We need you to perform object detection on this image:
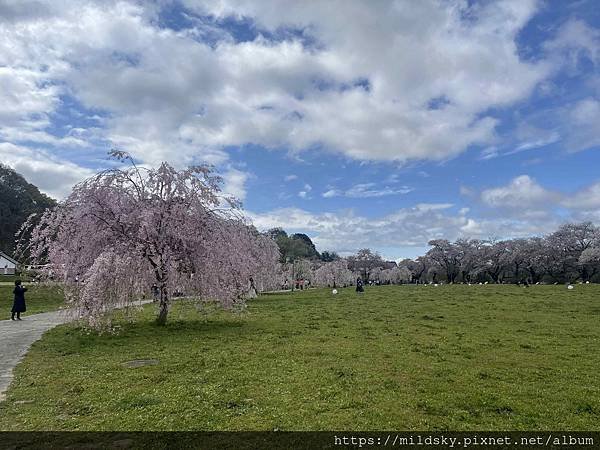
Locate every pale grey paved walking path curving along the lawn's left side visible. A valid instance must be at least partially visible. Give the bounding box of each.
[0,300,151,402]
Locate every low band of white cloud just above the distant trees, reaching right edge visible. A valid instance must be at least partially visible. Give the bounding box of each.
[249,175,600,258]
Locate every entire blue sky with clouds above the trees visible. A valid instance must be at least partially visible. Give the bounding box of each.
[0,0,600,259]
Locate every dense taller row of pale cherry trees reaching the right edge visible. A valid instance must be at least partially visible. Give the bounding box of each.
[414,222,600,283]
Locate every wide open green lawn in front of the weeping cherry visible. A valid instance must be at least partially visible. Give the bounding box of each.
[0,285,600,430]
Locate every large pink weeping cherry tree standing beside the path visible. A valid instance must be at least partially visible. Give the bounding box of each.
[20,151,279,324]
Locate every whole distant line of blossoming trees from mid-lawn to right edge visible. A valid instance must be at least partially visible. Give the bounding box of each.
[288,222,600,286]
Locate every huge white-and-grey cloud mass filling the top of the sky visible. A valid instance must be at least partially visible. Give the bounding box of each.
[0,0,549,172]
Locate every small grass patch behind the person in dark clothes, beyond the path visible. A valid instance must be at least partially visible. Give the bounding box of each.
[0,283,64,316]
